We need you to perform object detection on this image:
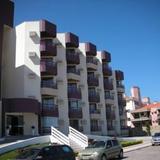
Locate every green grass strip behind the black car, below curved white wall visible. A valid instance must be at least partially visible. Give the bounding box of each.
[0,143,48,160]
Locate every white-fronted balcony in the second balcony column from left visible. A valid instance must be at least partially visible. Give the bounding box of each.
[67,68,80,81]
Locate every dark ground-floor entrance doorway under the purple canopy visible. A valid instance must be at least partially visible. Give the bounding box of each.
[6,115,23,136]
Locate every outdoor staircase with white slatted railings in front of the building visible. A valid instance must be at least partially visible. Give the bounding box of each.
[50,127,88,152]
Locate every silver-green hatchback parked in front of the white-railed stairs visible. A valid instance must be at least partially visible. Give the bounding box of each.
[78,138,123,160]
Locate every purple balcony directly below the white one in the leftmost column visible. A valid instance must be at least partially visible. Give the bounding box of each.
[42,104,59,117]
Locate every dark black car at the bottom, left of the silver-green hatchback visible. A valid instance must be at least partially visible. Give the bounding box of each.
[16,145,75,160]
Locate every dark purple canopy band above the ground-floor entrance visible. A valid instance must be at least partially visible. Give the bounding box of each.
[2,98,40,114]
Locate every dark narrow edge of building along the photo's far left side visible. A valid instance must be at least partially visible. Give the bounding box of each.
[0,0,14,135]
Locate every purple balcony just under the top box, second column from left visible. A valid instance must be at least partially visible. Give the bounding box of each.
[66,52,80,65]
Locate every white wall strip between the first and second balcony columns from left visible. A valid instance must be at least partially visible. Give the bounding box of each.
[57,33,69,134]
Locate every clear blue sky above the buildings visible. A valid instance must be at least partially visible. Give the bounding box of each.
[14,0,160,101]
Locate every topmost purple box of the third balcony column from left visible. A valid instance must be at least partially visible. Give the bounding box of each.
[85,43,97,56]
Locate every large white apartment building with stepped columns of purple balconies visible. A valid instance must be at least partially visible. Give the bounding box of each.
[2,20,128,138]
